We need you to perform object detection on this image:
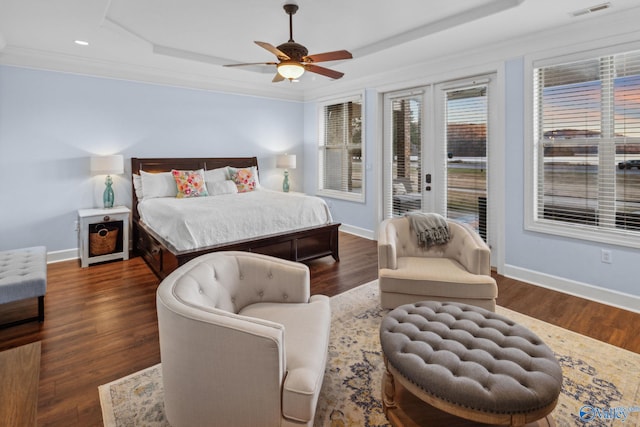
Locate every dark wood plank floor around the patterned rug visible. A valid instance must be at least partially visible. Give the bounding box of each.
[0,233,640,427]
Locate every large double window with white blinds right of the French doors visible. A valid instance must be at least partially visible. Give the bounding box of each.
[532,51,640,246]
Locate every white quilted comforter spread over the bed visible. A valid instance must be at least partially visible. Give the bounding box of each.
[138,189,332,251]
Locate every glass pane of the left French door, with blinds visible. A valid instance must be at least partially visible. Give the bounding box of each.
[391,95,422,216]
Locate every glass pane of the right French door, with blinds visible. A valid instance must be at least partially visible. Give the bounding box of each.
[445,85,488,240]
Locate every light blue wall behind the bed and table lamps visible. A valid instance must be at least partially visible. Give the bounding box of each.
[0,66,304,252]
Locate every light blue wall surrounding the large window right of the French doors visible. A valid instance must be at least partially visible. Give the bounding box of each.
[504,58,640,298]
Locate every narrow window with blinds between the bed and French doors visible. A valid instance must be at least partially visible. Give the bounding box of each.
[318,96,364,201]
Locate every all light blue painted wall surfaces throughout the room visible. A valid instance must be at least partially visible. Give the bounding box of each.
[0,58,640,295]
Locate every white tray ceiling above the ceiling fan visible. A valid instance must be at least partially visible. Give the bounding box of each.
[0,0,637,98]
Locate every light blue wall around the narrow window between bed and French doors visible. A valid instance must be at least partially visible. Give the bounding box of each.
[304,89,379,237]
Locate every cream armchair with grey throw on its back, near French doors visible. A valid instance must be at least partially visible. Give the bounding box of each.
[378,217,498,311]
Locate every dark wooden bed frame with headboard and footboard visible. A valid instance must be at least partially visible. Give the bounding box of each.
[131,157,340,279]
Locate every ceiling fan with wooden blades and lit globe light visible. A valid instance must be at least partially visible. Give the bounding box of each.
[225,4,353,83]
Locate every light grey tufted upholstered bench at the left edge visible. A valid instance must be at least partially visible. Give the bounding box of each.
[0,246,47,327]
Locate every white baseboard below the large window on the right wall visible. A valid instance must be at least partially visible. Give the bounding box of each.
[503,265,640,313]
